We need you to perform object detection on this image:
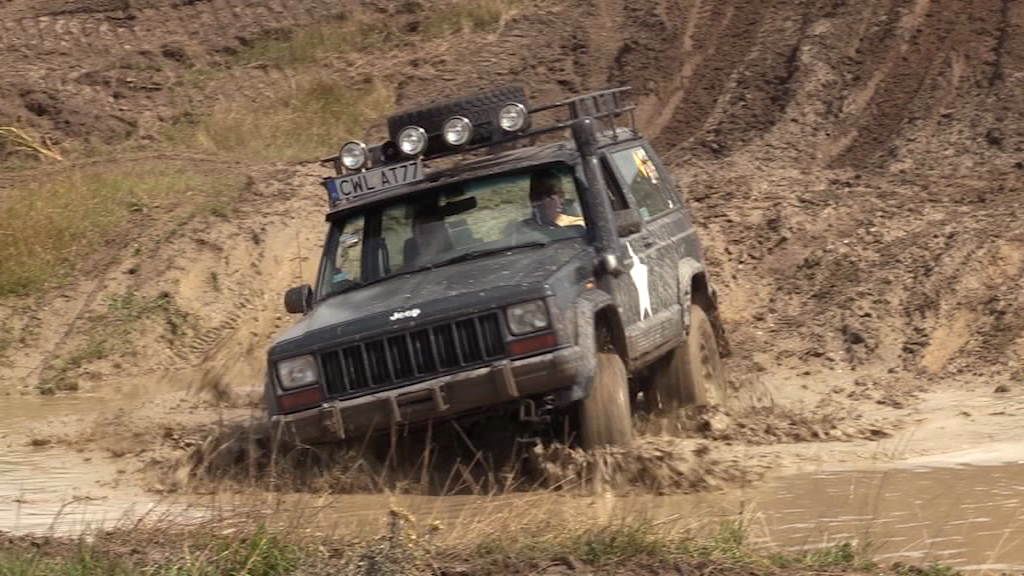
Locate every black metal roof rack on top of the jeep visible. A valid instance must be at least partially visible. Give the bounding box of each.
[319,86,637,175]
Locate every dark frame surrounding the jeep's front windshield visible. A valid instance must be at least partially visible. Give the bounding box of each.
[313,155,594,301]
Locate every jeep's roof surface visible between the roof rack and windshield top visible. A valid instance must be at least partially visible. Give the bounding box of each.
[327,128,643,219]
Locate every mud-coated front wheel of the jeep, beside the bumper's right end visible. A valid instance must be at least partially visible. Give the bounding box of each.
[580,344,633,450]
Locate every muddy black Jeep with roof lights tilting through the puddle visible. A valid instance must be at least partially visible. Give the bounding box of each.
[266,86,727,447]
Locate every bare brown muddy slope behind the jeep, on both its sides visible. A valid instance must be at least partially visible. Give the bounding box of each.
[0,0,1024,389]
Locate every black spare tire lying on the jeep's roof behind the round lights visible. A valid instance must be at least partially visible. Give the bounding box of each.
[387,84,526,141]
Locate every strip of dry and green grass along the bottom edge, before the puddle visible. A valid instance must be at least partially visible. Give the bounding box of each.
[0,500,929,576]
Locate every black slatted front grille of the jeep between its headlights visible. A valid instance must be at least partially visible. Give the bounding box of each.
[321,312,507,396]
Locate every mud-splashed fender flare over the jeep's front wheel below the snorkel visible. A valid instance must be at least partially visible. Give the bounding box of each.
[555,290,629,406]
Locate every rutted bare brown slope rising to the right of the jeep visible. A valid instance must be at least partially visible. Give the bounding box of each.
[389,0,1024,373]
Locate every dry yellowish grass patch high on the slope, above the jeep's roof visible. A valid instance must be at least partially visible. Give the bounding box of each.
[164,0,522,161]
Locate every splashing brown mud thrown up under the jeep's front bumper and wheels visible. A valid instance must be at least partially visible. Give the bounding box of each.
[161,399,889,495]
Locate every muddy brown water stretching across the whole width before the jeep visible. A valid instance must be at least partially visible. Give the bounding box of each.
[0,395,1024,571]
